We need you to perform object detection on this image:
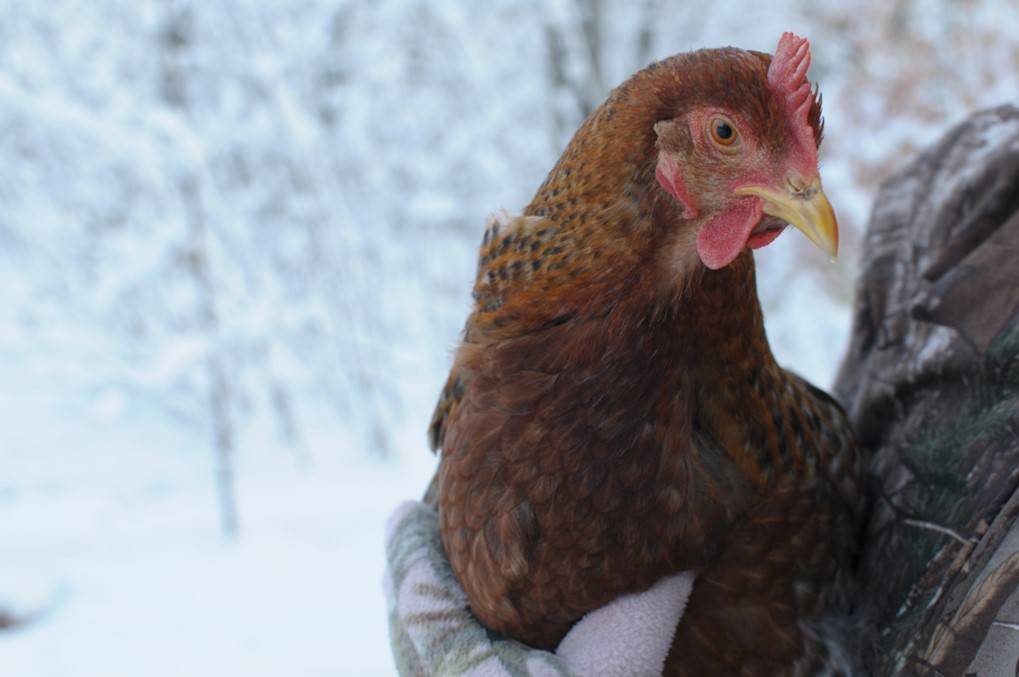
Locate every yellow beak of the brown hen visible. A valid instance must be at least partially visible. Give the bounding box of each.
[736,177,839,259]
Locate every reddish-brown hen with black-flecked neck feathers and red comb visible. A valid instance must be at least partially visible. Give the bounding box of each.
[430,34,861,675]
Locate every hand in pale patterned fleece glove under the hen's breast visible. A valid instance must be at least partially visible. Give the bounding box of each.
[384,502,693,677]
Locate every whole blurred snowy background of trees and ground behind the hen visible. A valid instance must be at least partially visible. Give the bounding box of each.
[0,0,1019,677]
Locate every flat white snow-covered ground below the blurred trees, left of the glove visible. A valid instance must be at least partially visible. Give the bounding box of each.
[0,465,434,677]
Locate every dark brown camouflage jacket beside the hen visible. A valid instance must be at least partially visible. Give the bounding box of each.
[835,106,1019,677]
